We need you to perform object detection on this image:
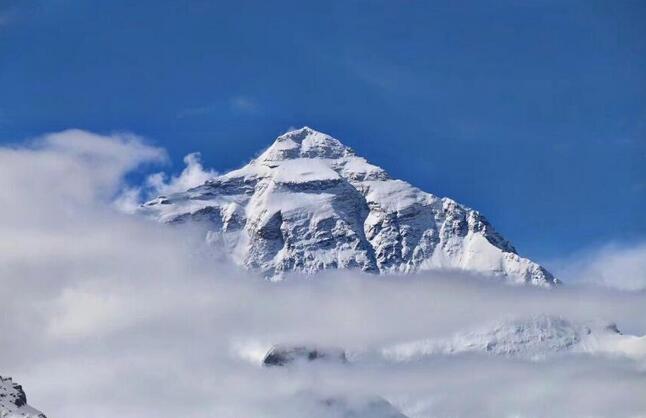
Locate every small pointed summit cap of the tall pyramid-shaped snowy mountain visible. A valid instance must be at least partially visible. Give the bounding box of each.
[259,126,354,161]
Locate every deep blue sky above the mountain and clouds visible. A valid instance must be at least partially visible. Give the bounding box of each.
[0,0,646,260]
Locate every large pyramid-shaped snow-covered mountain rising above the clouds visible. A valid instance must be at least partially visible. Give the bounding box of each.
[141,127,556,286]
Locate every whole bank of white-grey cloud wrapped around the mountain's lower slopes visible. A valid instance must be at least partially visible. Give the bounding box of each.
[0,130,646,418]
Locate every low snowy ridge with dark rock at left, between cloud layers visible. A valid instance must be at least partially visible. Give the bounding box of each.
[253,315,646,367]
